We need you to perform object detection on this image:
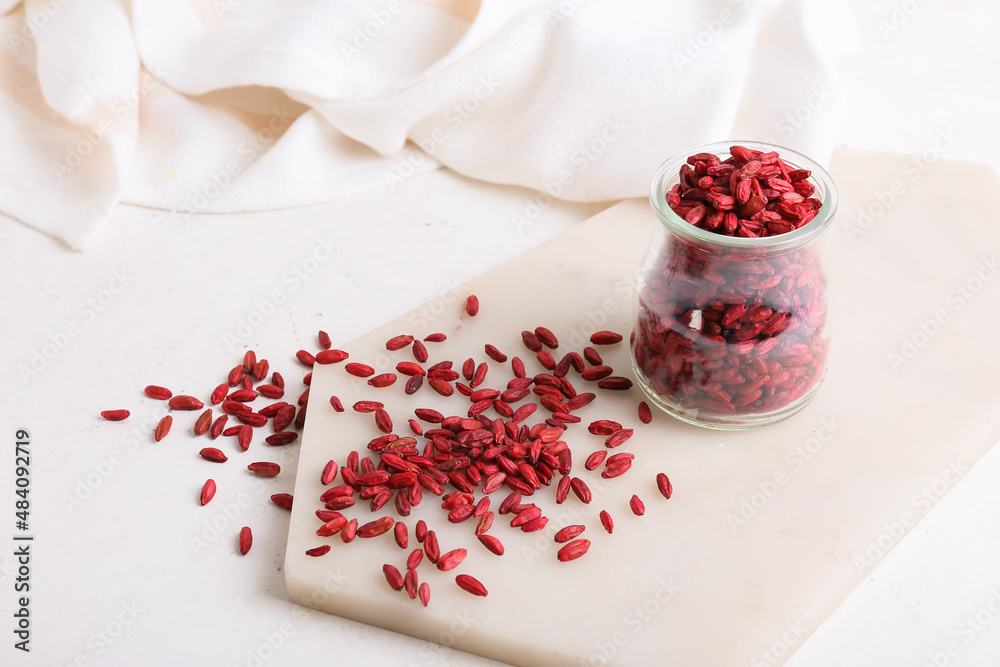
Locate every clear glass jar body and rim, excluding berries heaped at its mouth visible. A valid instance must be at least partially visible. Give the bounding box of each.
[632,141,837,429]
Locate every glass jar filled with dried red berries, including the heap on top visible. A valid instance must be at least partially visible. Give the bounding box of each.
[632,141,837,429]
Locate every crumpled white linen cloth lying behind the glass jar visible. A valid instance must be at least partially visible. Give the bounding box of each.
[0,0,851,249]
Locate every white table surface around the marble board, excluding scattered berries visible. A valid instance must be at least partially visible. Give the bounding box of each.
[0,0,1000,667]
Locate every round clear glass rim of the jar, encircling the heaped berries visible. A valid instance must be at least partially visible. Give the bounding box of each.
[649,139,838,251]
